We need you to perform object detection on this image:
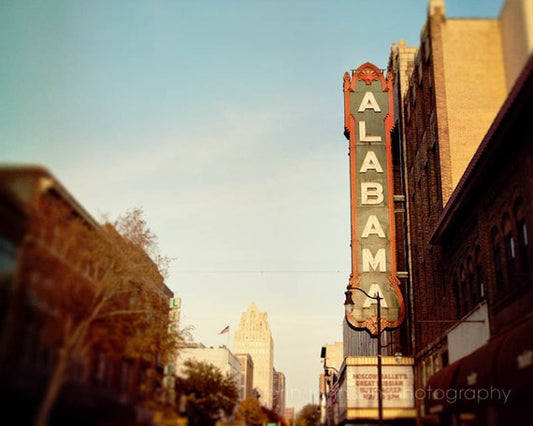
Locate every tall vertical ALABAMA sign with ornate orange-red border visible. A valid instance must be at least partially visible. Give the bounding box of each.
[343,62,405,334]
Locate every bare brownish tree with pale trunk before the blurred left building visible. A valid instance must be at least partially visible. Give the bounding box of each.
[26,198,177,426]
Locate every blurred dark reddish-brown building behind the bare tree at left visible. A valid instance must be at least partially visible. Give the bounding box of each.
[0,166,172,425]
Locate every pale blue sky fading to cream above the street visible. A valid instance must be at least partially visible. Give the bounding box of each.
[0,0,502,410]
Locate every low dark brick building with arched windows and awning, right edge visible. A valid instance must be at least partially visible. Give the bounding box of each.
[420,57,533,425]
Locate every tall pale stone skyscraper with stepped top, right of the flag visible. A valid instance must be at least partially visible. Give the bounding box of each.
[233,302,274,408]
